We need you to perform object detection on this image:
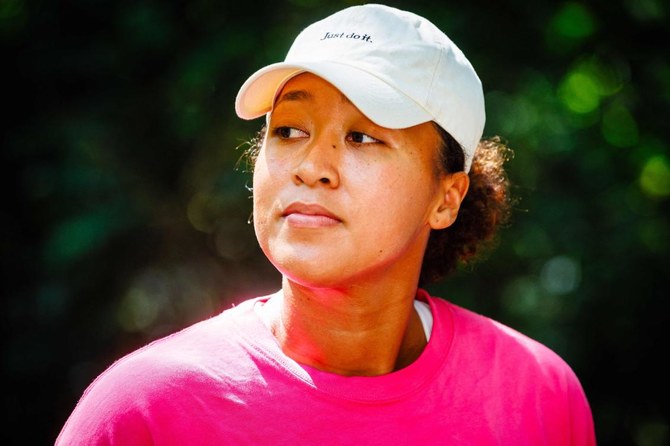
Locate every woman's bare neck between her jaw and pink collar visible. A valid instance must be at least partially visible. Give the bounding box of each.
[263,278,426,376]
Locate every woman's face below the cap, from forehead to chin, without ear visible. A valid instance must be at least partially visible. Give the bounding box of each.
[253,74,452,287]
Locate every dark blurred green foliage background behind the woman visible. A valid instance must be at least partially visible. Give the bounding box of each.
[0,0,670,446]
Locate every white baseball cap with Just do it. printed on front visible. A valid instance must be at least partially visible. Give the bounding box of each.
[235,4,486,172]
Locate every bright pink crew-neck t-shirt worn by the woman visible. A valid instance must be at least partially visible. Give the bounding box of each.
[56,291,595,446]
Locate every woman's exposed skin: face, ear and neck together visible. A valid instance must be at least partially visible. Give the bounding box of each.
[254,74,468,375]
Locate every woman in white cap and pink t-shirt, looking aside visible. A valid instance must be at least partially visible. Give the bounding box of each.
[57,5,595,445]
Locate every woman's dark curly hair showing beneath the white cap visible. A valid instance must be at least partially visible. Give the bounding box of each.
[242,123,512,286]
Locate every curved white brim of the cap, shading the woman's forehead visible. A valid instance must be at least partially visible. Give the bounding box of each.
[235,61,433,129]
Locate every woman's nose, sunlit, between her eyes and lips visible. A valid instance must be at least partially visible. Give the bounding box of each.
[293,138,341,188]
